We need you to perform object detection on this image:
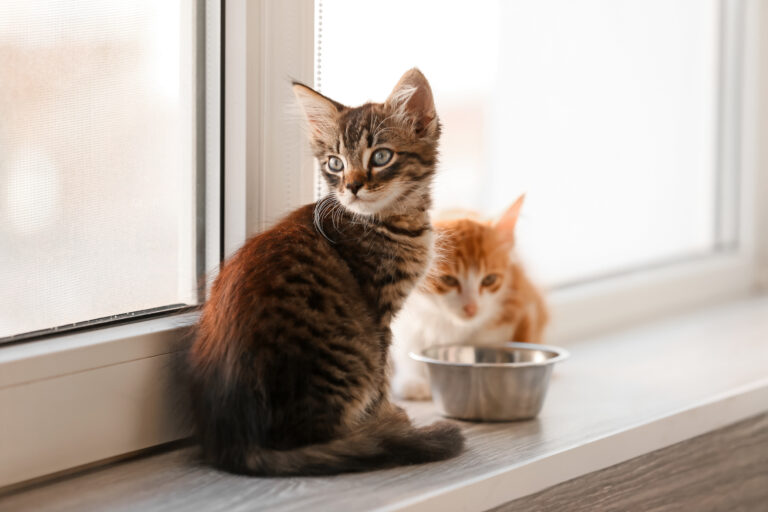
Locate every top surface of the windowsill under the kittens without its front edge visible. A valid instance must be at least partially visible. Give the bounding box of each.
[0,298,768,512]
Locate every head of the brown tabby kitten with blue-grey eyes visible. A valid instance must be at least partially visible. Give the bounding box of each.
[293,68,440,215]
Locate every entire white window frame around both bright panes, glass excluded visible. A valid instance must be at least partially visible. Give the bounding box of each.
[0,0,768,487]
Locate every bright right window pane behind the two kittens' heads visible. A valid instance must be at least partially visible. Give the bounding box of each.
[316,0,737,286]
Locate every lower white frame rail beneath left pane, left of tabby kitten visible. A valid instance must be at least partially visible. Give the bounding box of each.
[0,312,198,488]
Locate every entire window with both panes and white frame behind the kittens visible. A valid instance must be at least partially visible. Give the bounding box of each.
[0,0,768,486]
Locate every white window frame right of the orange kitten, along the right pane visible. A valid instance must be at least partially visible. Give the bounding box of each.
[549,0,768,343]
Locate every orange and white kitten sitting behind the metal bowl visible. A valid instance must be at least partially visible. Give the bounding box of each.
[391,196,548,400]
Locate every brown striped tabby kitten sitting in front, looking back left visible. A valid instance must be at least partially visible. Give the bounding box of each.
[188,69,464,475]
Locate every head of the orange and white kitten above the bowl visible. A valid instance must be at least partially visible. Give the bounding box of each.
[422,196,524,324]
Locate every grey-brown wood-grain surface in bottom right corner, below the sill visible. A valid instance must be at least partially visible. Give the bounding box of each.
[494,415,768,512]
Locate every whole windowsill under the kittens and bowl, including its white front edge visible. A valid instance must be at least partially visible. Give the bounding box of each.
[4,296,768,510]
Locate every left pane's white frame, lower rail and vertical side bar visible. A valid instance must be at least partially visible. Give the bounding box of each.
[0,0,228,487]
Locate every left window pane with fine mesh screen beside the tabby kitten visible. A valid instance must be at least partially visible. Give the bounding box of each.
[0,0,210,340]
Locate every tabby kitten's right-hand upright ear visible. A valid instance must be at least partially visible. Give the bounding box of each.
[385,68,438,136]
